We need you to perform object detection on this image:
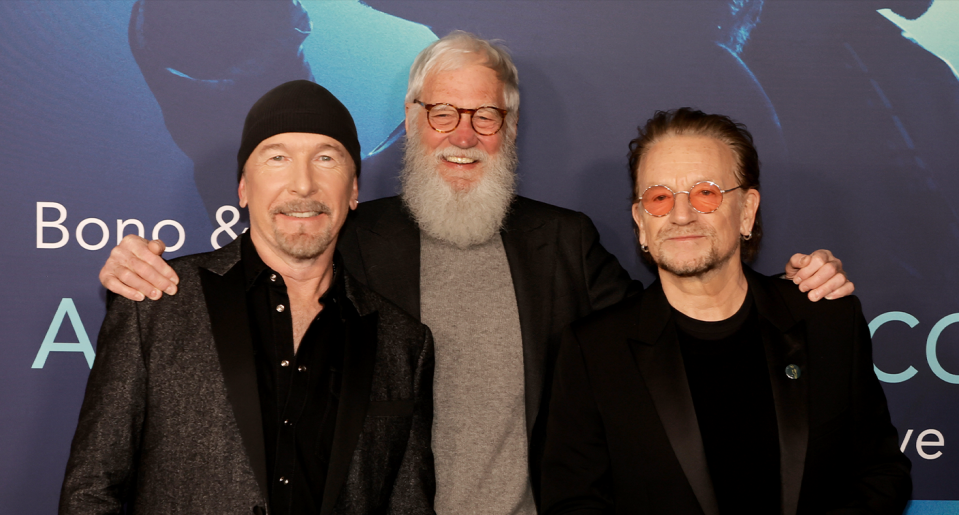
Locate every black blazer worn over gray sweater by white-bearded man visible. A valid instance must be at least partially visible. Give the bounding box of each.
[337,197,642,502]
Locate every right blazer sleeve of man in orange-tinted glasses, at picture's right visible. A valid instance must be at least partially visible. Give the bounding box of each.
[832,297,912,515]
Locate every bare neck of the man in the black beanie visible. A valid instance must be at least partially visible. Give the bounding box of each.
[250,230,336,300]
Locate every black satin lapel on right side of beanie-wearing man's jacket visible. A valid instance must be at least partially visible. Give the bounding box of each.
[320,311,379,515]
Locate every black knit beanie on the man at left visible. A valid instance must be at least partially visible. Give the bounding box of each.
[236,80,360,181]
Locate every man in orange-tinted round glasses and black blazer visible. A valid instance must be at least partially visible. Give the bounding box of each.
[543,108,912,515]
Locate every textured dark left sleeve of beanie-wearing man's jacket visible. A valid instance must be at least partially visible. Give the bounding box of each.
[59,298,146,515]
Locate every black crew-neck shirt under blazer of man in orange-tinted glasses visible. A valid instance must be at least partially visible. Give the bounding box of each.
[673,293,782,514]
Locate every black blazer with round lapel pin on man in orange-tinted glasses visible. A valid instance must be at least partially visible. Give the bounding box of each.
[543,269,912,515]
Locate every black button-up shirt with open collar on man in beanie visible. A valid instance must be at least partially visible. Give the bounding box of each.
[241,235,349,515]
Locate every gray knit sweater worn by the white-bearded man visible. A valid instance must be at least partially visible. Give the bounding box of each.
[420,234,536,515]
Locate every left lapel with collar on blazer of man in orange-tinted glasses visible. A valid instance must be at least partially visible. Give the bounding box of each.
[630,281,719,515]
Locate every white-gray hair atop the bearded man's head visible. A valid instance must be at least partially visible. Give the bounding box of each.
[406,30,519,134]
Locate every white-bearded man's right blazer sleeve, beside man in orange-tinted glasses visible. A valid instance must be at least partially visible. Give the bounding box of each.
[579,214,643,311]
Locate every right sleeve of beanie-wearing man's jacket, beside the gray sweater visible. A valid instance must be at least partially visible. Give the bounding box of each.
[390,326,436,515]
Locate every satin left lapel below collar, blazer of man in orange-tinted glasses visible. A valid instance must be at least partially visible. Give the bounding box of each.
[631,322,719,515]
